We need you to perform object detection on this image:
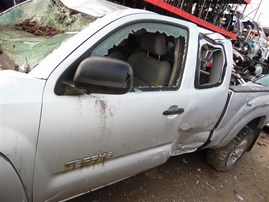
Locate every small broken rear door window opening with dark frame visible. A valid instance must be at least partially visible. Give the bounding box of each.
[196,43,225,87]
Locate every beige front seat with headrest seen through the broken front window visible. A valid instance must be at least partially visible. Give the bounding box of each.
[128,33,171,86]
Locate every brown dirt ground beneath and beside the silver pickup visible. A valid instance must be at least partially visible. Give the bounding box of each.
[70,130,269,202]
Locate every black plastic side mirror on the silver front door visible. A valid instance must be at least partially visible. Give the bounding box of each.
[73,56,133,94]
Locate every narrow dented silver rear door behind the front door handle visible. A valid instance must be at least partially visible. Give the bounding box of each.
[179,37,231,151]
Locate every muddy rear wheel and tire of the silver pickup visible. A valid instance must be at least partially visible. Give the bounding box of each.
[207,126,255,171]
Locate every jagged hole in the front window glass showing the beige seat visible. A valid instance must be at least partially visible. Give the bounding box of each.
[106,30,185,88]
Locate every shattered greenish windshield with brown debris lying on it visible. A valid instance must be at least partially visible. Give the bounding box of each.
[0,0,96,73]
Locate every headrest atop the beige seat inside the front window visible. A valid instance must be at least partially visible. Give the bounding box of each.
[140,33,166,56]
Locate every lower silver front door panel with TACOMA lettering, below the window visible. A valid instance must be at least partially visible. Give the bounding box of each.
[35,90,186,200]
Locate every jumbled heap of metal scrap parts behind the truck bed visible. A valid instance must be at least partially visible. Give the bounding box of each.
[232,21,269,85]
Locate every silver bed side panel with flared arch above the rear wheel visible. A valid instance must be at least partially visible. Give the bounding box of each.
[207,92,269,147]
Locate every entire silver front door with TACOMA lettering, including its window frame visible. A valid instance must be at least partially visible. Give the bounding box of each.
[34,18,188,200]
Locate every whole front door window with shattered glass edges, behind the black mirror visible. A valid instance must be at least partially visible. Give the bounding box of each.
[55,23,188,95]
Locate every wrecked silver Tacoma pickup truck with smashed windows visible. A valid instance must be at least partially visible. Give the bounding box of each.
[0,0,269,201]
